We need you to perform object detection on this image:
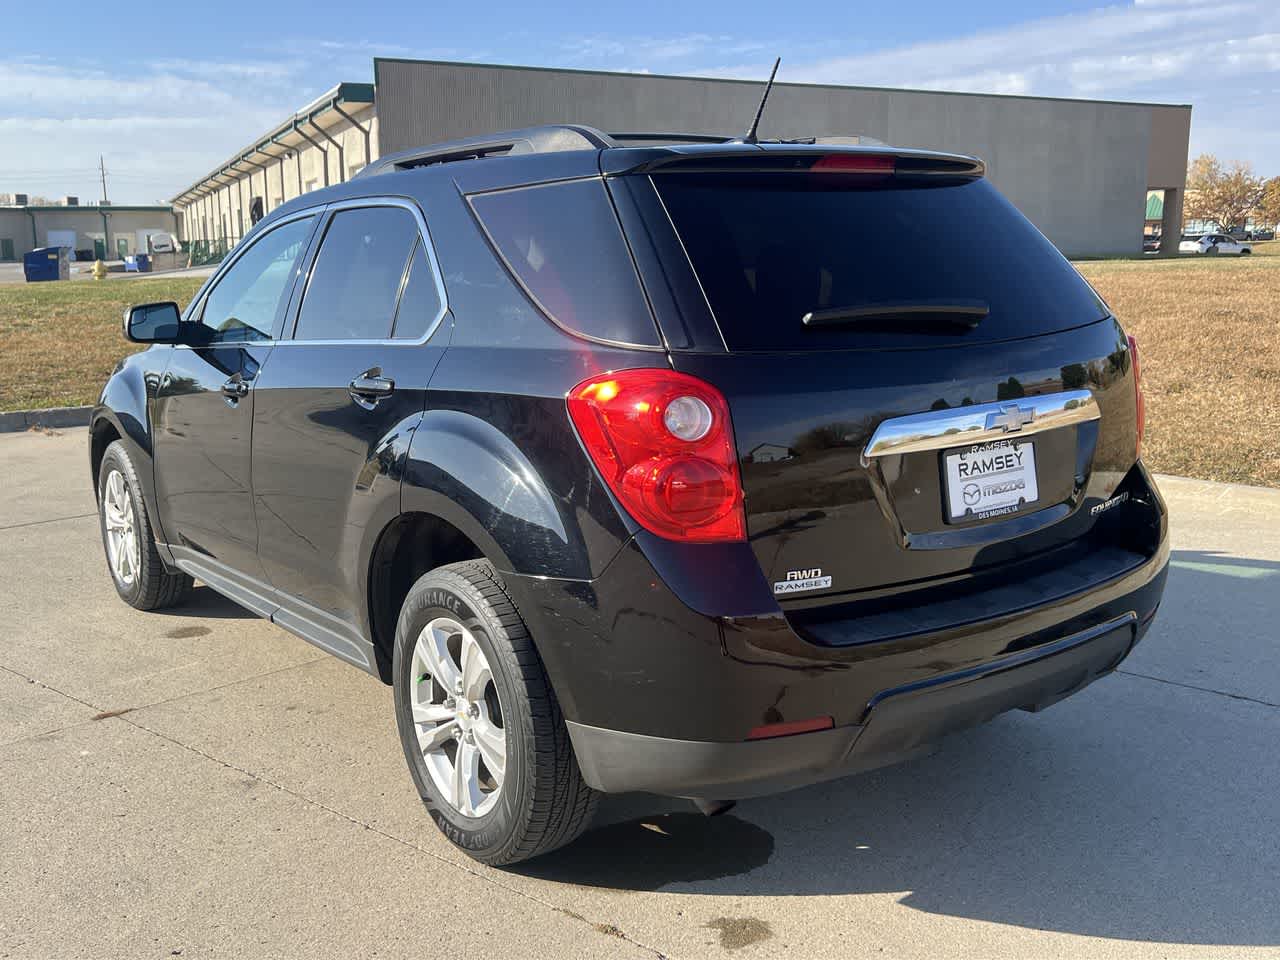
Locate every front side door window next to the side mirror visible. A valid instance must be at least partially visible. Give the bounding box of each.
[197,216,311,343]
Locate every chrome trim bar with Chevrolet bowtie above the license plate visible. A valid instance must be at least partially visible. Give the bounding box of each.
[863,390,1101,465]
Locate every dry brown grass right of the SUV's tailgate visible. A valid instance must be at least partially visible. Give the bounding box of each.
[1079,242,1280,486]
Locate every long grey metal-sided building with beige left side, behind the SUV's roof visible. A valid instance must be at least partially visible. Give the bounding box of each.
[173,59,1192,256]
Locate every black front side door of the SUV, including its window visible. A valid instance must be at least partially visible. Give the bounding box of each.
[152,215,316,586]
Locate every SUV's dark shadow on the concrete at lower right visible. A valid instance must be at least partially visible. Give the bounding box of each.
[520,552,1280,946]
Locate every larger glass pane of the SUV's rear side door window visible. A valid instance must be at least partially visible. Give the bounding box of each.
[293,206,417,340]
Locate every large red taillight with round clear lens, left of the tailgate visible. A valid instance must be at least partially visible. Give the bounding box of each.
[567,370,746,543]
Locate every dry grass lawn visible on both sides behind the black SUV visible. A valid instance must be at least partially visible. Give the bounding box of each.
[0,241,1280,486]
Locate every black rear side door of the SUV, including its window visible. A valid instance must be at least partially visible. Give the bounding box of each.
[253,198,451,666]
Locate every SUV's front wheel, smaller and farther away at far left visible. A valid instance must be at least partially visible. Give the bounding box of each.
[97,440,192,611]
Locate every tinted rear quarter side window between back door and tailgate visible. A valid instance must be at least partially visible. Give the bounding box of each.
[471,179,659,347]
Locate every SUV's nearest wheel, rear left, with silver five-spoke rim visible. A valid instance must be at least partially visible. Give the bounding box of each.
[393,561,596,865]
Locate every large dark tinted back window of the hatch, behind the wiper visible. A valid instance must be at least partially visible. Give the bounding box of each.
[654,173,1107,351]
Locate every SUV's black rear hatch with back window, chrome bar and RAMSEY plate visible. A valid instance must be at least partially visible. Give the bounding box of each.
[614,148,1137,608]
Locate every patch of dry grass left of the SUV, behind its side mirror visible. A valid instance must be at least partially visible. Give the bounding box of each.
[0,276,204,412]
